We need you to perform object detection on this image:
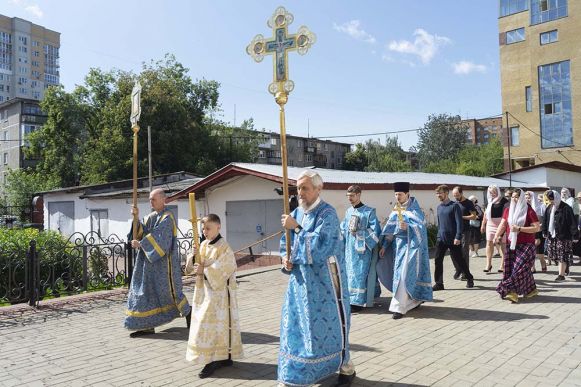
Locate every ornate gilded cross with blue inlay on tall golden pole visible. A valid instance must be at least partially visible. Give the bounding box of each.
[246,7,316,257]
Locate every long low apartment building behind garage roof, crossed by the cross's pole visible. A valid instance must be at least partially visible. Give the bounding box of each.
[256,132,351,169]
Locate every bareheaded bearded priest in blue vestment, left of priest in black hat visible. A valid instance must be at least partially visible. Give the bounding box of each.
[341,185,381,312]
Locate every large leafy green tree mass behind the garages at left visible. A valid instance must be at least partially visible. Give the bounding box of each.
[27,55,254,187]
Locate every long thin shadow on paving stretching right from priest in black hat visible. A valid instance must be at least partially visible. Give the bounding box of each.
[406,306,554,321]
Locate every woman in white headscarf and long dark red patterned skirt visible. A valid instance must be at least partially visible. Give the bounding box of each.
[495,189,540,303]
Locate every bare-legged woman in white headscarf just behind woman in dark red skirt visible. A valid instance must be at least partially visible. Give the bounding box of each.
[480,185,508,273]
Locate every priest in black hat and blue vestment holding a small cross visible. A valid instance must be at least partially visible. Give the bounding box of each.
[380,182,433,319]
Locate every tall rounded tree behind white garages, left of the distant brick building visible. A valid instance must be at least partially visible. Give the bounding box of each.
[417,113,468,172]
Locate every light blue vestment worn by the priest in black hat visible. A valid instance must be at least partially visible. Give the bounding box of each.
[382,197,433,313]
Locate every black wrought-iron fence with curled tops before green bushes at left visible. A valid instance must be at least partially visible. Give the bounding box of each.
[0,232,197,306]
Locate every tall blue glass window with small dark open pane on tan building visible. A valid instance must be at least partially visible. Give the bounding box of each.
[539,60,573,148]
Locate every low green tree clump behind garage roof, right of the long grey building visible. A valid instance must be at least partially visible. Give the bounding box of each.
[344,136,411,172]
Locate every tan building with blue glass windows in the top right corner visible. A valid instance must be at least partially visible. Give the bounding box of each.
[498,0,581,169]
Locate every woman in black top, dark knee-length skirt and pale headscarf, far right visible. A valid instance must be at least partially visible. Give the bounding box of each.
[543,191,579,281]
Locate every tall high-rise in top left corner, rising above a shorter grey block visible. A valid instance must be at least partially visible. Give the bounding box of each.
[0,15,60,103]
